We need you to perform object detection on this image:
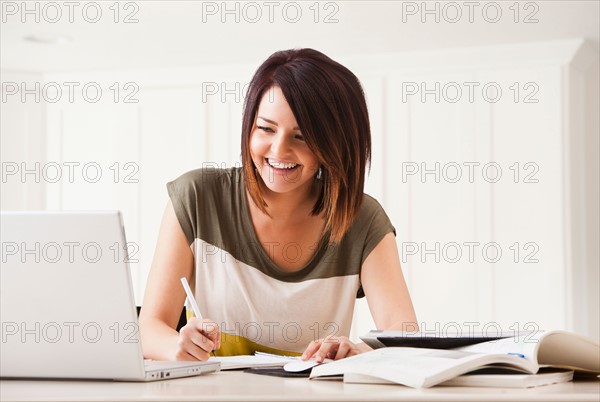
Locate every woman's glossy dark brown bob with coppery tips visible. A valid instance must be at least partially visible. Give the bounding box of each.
[242,48,371,243]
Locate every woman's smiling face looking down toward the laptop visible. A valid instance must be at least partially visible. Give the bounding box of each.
[250,86,319,193]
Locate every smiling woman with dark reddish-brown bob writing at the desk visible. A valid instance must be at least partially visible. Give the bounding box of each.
[140,49,417,361]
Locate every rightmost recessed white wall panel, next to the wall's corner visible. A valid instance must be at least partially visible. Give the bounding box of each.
[484,67,567,328]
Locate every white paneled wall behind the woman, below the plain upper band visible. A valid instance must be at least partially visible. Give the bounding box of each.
[2,40,598,338]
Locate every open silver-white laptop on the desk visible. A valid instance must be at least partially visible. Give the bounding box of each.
[0,211,220,381]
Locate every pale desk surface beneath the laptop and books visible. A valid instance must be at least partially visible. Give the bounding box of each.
[0,371,600,402]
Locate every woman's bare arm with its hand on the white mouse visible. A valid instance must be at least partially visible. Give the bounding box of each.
[302,232,419,361]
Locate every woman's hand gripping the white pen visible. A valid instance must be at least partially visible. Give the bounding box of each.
[175,318,221,361]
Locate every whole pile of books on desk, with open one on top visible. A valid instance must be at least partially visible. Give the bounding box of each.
[310,331,600,388]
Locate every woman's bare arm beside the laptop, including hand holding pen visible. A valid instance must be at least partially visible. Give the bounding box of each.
[139,200,220,360]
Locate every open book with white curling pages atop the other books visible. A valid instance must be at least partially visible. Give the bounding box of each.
[310,331,600,388]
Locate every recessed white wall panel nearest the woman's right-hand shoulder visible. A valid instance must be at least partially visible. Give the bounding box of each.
[393,72,485,329]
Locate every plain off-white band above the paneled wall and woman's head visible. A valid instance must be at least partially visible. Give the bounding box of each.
[0,0,600,72]
